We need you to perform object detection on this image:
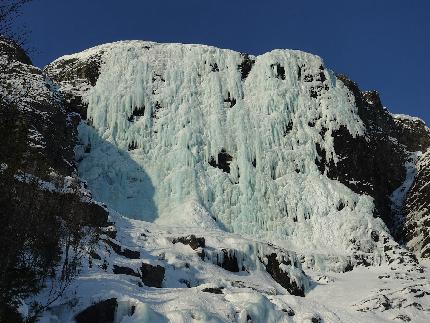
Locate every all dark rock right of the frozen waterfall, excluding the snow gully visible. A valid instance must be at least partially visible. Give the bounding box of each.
[332,75,430,257]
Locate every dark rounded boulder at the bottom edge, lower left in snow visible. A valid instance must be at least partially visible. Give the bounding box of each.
[75,298,118,323]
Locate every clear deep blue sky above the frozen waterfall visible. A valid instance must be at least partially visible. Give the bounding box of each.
[22,0,430,124]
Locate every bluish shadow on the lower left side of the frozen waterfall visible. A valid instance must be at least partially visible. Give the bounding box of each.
[76,123,158,222]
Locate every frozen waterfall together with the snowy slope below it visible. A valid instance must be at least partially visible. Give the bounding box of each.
[17,42,430,322]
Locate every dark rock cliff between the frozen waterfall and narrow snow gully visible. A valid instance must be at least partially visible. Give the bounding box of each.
[321,75,430,241]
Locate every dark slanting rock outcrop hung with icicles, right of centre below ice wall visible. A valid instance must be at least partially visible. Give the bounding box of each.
[266,253,305,296]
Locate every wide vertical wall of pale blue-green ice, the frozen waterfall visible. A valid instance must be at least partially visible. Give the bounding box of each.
[73,42,379,253]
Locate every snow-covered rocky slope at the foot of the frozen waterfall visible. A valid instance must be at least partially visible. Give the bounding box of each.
[34,209,430,323]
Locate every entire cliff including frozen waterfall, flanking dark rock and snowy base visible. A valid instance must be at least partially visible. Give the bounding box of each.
[0,40,430,322]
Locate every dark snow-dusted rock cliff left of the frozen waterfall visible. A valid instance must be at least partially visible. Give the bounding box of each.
[0,38,76,180]
